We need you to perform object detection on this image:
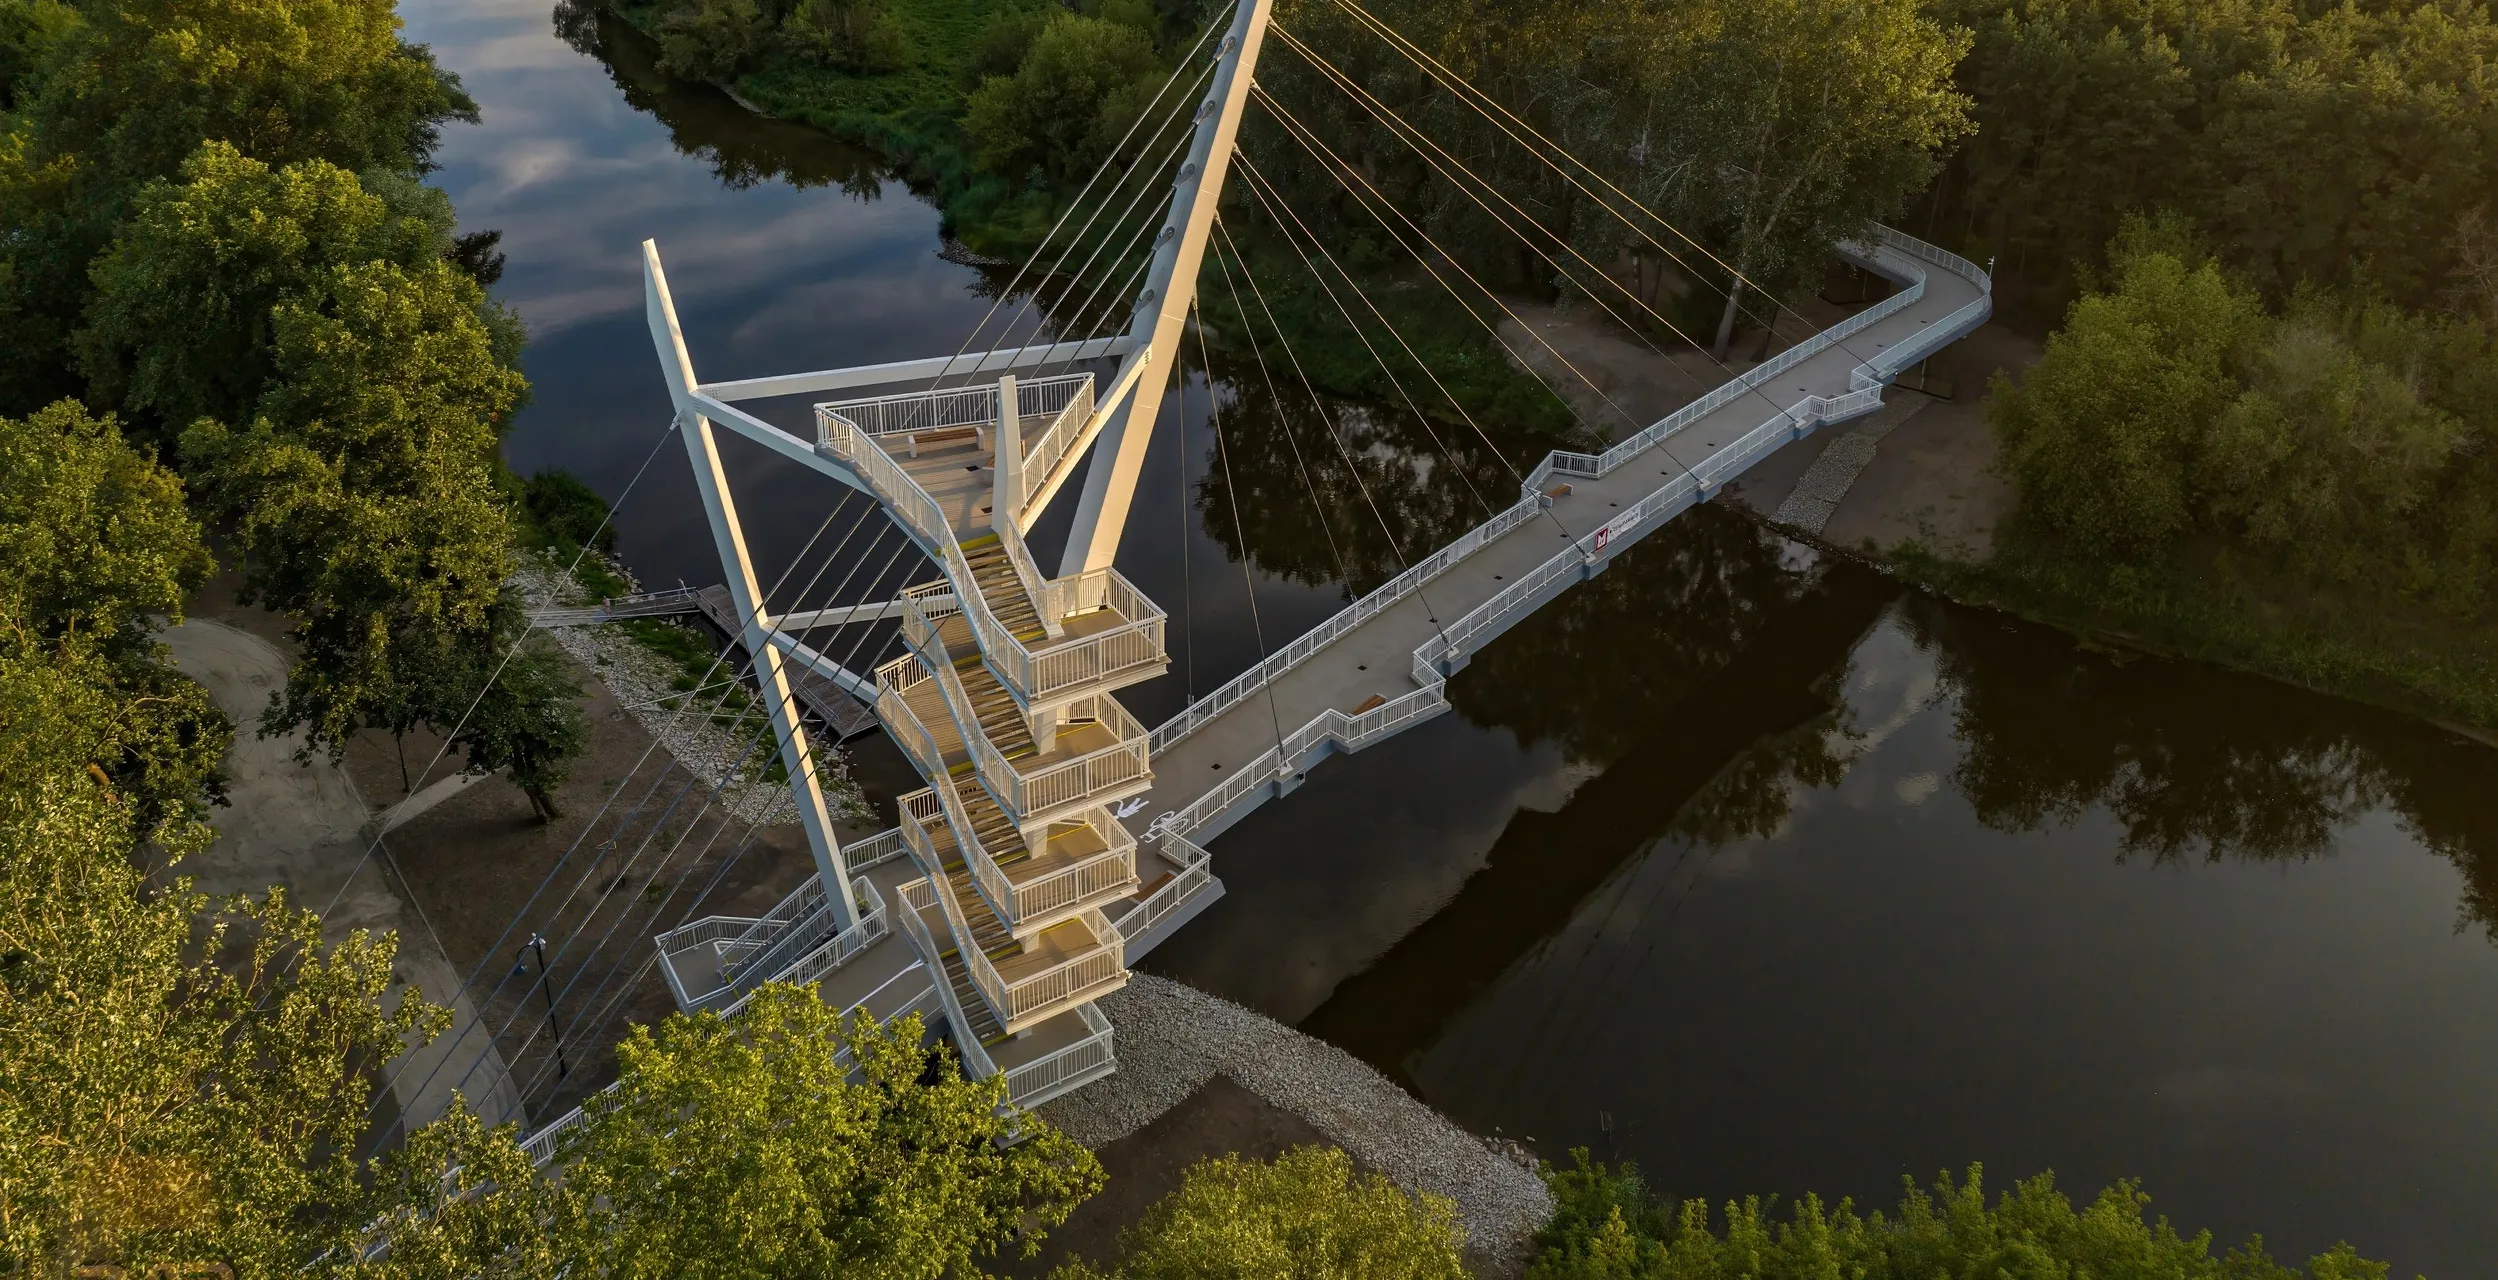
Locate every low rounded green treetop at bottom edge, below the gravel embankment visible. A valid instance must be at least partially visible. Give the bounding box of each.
[1059,1148,1466,1280]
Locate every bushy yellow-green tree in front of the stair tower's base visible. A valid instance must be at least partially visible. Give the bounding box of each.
[354,983,1102,1280]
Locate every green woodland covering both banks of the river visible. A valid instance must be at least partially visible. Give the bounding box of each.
[0,0,2458,1280]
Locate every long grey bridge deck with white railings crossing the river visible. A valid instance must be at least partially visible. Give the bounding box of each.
[1127,230,1991,890]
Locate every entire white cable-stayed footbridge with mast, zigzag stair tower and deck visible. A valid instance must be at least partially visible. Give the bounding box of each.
[517,0,1988,1150]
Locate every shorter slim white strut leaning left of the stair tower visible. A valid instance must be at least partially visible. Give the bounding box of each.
[642,240,859,930]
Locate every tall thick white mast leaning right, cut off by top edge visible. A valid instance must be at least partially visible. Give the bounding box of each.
[1059,0,1274,575]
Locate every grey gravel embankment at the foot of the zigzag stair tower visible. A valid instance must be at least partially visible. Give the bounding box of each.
[1042,973,1551,1260]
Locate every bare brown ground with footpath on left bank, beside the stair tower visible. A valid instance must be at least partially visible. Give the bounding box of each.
[175,575,892,1125]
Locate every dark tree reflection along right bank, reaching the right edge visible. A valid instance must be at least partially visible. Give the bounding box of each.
[1906,598,2498,940]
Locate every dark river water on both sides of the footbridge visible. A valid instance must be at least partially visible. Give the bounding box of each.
[407,0,2498,1278]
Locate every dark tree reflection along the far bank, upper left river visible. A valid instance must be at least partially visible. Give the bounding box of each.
[555,0,884,200]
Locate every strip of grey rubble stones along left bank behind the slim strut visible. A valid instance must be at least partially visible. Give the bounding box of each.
[512,558,864,825]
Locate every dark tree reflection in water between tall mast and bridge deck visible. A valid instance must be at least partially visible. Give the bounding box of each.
[1189,350,1519,595]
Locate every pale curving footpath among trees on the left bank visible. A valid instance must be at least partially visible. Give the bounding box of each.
[157,618,517,1125]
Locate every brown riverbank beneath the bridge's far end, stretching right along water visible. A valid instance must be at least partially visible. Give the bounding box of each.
[1578,297,2498,743]
